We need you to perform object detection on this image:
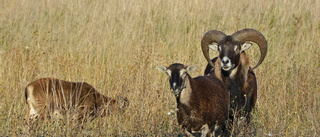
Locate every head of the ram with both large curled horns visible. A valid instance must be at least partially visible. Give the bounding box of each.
[201,29,267,76]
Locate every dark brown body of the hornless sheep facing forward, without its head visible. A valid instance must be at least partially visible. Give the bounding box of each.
[177,76,229,135]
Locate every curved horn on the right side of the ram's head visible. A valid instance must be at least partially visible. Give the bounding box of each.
[232,29,268,69]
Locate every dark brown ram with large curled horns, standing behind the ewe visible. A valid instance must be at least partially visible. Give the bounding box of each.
[201,29,267,127]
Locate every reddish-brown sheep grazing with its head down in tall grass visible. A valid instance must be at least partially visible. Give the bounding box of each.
[25,78,129,122]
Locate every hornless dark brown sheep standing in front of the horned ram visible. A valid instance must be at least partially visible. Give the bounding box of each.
[157,63,230,136]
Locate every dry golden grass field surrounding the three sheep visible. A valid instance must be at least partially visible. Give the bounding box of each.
[0,0,320,136]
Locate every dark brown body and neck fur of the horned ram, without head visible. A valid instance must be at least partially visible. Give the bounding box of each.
[205,52,257,122]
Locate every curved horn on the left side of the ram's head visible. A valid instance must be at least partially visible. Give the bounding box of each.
[201,30,227,67]
